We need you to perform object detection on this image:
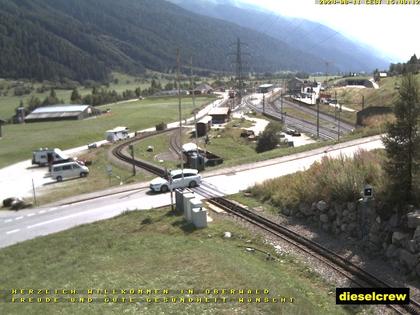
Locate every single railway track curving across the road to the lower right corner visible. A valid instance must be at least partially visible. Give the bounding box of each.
[112,124,420,315]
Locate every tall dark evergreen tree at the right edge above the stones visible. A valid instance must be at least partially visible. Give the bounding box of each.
[383,74,420,209]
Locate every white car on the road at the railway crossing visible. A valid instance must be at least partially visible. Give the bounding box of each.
[150,168,201,193]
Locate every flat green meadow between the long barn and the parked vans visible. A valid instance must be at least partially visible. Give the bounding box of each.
[0,97,214,167]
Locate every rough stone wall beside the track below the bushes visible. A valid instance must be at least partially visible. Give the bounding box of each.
[281,199,420,277]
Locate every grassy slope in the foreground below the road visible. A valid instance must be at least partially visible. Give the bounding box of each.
[0,209,363,314]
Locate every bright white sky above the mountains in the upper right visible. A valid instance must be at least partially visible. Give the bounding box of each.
[240,0,420,62]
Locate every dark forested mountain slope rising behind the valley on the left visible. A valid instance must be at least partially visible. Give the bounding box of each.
[0,0,334,81]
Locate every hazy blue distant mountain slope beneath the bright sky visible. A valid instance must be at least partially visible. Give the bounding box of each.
[169,0,389,71]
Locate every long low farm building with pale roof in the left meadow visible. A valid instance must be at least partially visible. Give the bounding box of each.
[25,105,101,123]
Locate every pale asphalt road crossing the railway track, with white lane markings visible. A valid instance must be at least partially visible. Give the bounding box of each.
[0,136,383,247]
